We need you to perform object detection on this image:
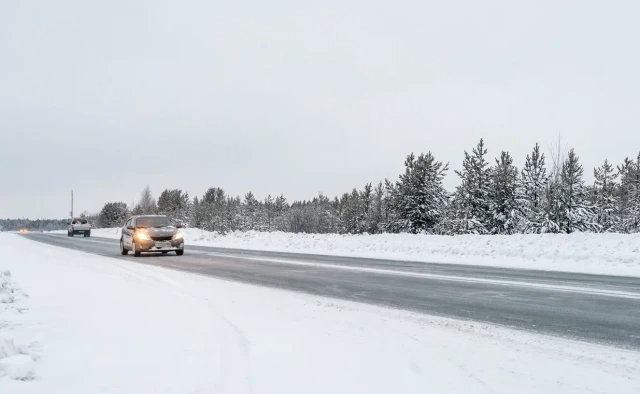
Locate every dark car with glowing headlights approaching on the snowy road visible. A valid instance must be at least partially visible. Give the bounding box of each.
[120,215,184,256]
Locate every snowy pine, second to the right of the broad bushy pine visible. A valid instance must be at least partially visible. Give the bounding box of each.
[489,151,521,234]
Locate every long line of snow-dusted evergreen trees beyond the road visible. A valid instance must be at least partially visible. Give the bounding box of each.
[98,140,640,235]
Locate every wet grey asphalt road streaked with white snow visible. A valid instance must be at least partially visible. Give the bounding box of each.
[25,233,640,349]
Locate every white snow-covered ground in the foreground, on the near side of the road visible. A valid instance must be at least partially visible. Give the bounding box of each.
[0,233,640,394]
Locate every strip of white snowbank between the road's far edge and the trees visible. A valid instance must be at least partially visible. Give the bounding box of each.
[52,228,640,276]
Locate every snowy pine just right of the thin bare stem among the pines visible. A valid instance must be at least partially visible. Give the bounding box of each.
[558,149,600,233]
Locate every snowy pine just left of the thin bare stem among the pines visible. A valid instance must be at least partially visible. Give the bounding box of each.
[518,144,557,234]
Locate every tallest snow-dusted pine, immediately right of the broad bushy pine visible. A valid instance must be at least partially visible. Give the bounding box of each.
[447,139,491,234]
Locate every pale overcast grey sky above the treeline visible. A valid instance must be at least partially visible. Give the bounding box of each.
[0,0,640,218]
